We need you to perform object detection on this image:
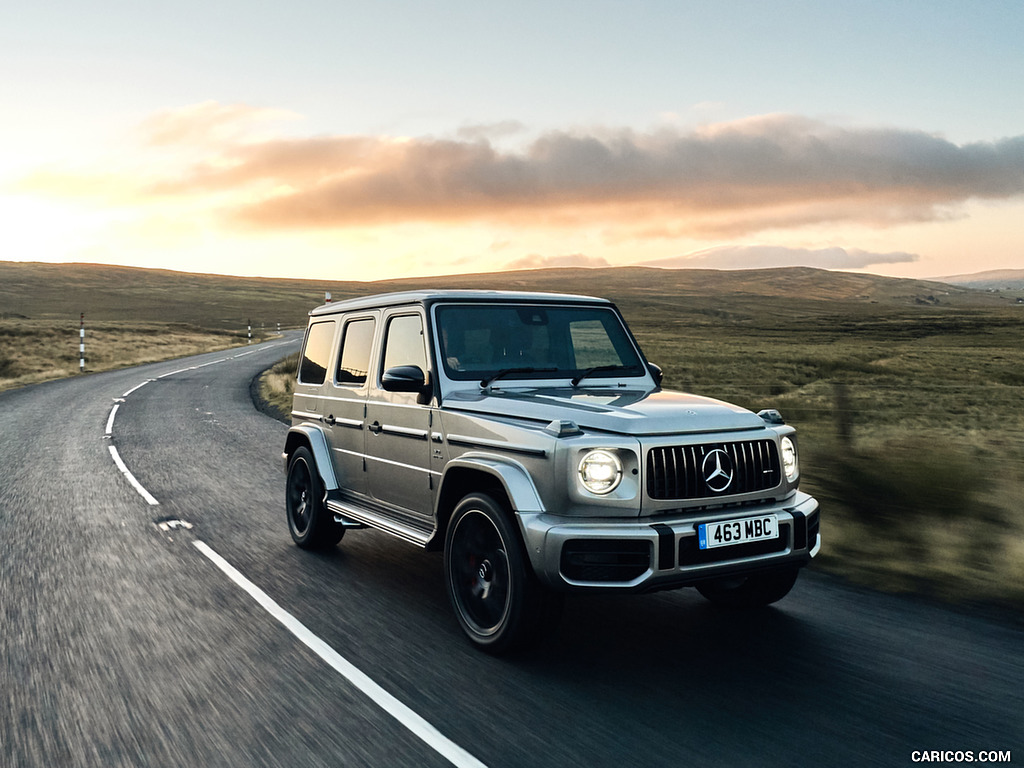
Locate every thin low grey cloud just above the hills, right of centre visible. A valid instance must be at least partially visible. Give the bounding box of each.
[639,246,920,269]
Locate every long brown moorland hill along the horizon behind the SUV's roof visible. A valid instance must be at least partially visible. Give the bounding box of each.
[0,261,1009,329]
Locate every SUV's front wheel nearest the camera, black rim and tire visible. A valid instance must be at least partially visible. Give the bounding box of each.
[444,494,561,655]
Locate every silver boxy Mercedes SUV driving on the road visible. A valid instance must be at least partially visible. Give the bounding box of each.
[283,291,821,653]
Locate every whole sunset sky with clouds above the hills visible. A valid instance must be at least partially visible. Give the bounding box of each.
[0,0,1024,281]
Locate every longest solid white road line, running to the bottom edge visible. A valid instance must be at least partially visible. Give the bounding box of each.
[194,541,485,768]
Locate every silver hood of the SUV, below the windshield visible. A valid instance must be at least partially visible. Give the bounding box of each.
[444,387,765,435]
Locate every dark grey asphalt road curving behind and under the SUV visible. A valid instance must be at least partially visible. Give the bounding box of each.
[0,342,1024,768]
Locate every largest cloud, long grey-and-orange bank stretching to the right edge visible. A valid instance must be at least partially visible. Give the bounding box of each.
[14,107,1024,240]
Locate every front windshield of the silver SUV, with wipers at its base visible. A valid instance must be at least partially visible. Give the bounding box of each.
[435,304,645,381]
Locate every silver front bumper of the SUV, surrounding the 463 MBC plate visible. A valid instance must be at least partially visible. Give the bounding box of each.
[519,493,821,592]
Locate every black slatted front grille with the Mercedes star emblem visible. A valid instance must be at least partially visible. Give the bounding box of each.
[647,440,782,500]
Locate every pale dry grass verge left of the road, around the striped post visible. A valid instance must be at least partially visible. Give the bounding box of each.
[0,319,272,390]
